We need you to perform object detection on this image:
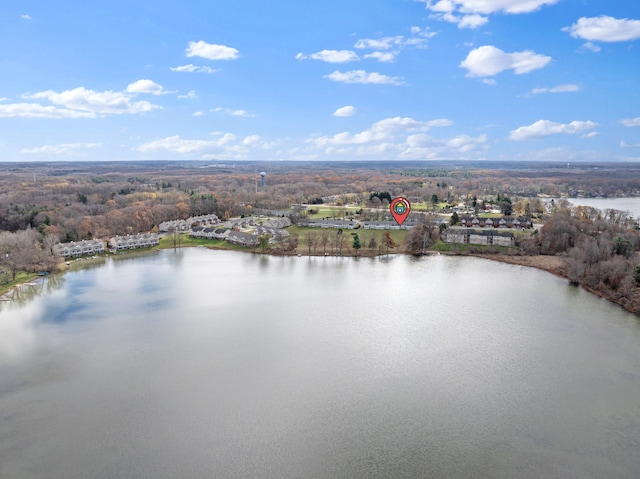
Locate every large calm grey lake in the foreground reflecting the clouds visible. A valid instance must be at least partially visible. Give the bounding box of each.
[0,249,640,479]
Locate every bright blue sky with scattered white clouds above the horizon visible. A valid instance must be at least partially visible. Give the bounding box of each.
[0,0,640,162]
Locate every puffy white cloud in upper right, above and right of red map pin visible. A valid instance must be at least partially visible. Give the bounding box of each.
[459,45,551,77]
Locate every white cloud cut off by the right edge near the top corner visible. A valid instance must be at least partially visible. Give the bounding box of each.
[562,15,640,42]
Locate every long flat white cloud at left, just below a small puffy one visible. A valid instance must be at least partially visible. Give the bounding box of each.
[23,87,162,115]
